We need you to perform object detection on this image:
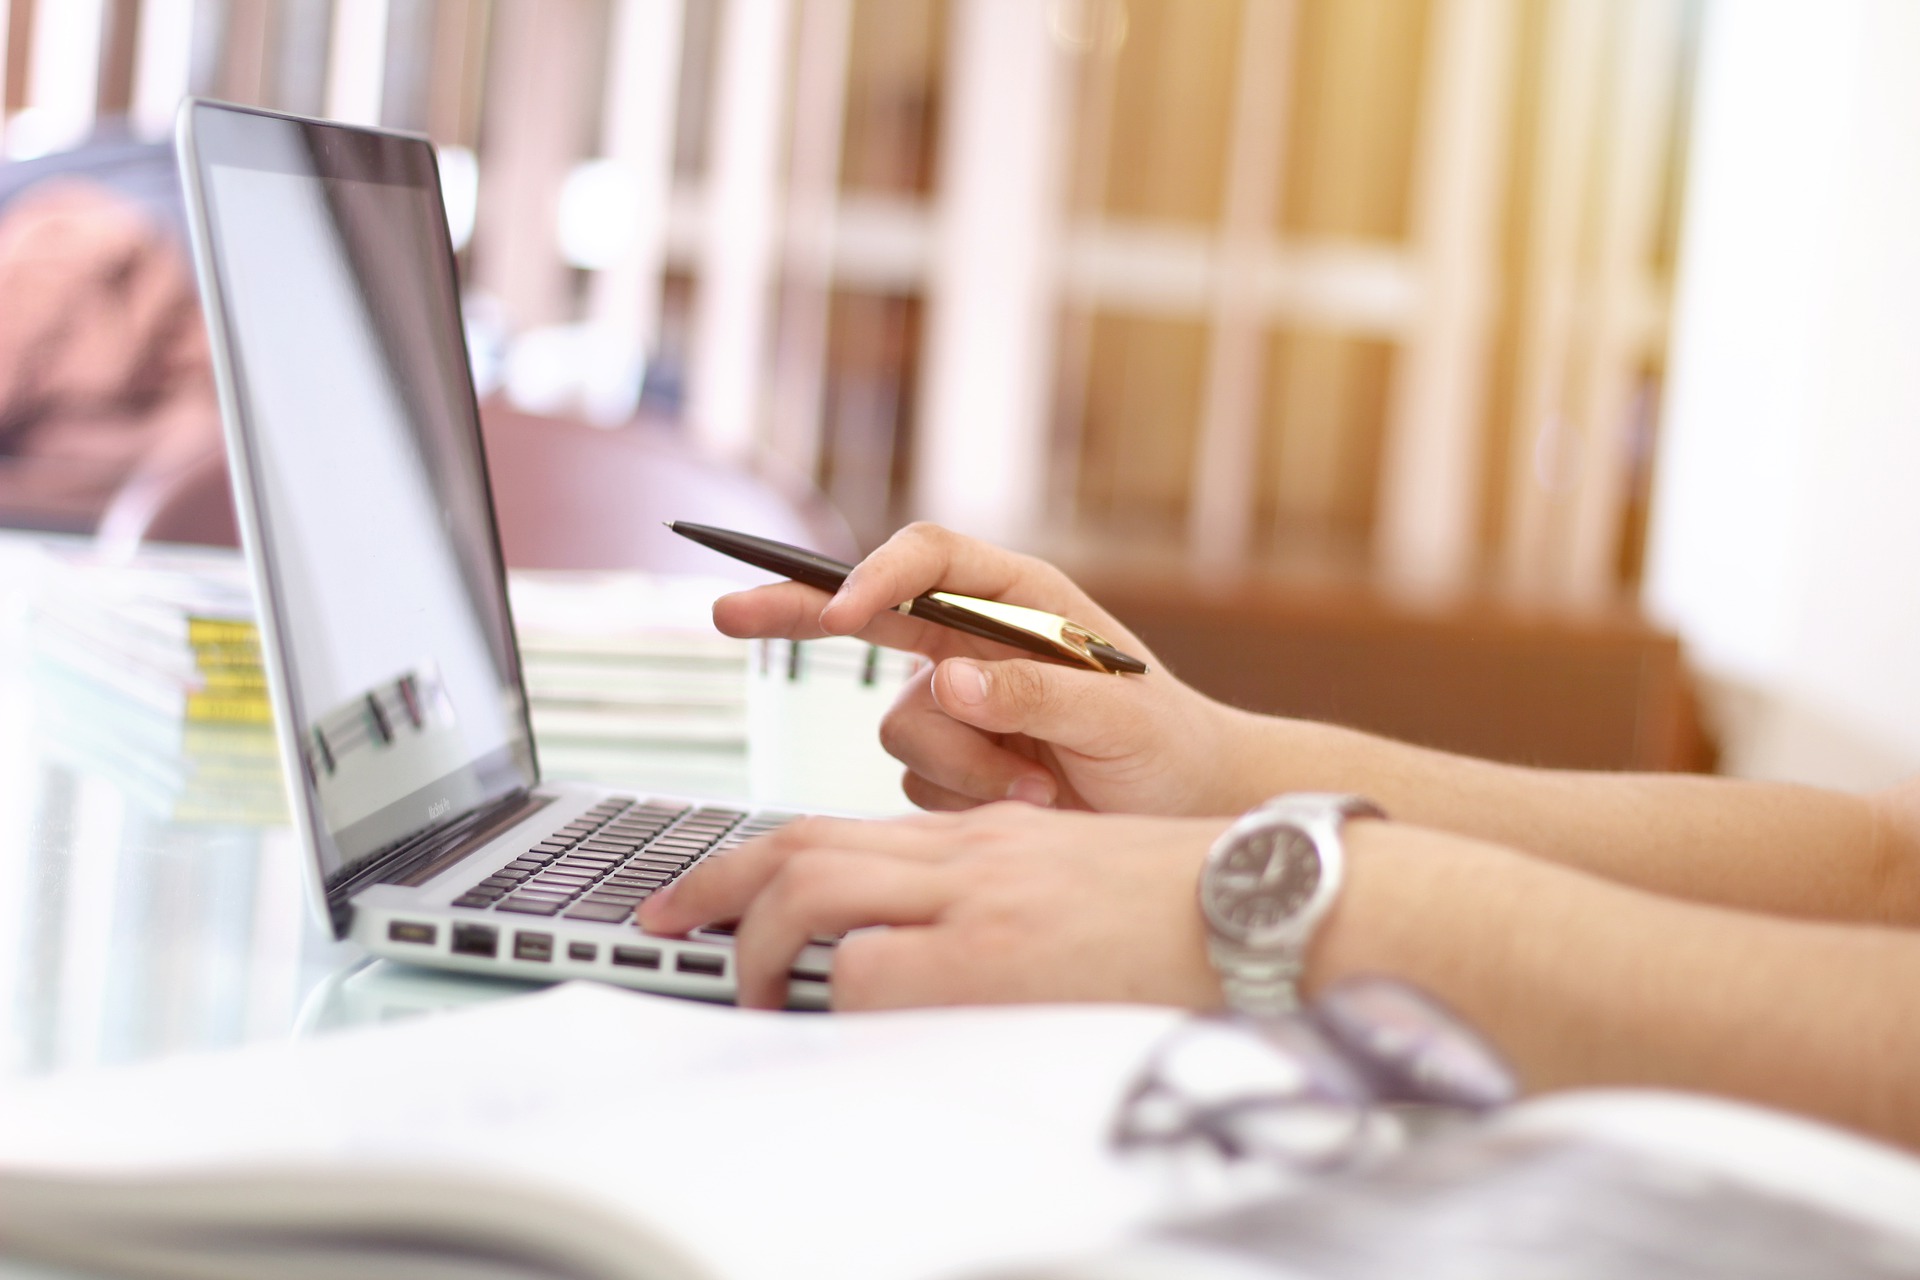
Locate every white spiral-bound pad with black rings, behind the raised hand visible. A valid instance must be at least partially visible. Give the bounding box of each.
[747,635,920,816]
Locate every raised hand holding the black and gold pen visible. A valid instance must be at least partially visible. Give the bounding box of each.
[714,524,1271,814]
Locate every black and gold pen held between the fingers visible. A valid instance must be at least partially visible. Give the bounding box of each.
[666,520,1146,676]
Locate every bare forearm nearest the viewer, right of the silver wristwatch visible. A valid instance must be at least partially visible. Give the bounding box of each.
[1309,823,1920,1146]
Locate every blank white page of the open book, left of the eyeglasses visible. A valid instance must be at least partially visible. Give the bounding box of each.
[0,984,1179,1280]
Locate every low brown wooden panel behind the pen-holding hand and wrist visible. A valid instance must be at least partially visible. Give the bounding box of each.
[1081,574,1713,770]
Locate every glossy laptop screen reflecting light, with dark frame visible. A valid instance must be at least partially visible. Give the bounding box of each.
[188,104,536,883]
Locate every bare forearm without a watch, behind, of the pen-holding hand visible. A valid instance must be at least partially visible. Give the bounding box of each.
[1229,718,1920,923]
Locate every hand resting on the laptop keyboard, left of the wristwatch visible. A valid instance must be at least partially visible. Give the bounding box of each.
[639,804,1223,1009]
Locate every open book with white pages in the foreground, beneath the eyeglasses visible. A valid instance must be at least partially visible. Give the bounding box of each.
[0,984,1920,1280]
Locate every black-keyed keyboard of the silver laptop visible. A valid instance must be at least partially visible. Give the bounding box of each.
[453,796,793,923]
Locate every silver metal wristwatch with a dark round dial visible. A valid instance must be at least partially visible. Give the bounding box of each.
[1200,791,1386,1015]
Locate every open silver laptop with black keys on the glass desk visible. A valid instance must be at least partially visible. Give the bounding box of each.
[179,100,829,1007]
